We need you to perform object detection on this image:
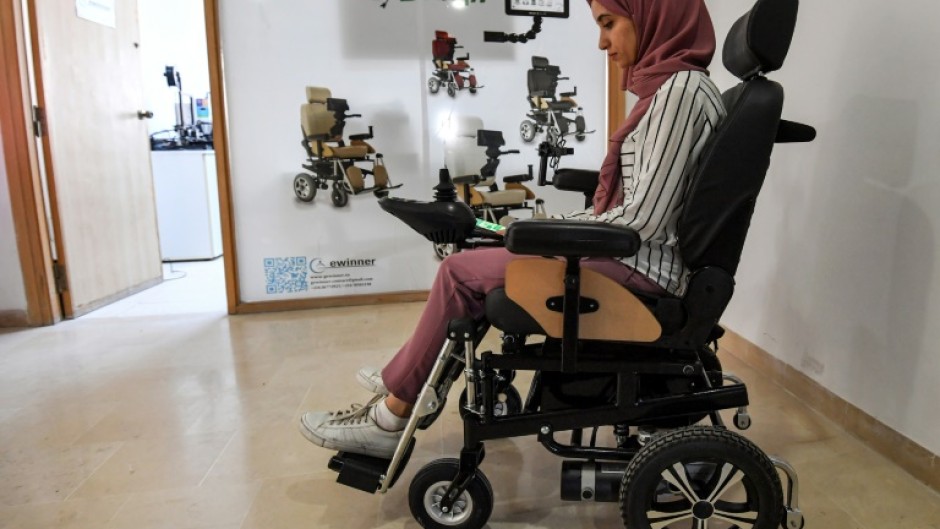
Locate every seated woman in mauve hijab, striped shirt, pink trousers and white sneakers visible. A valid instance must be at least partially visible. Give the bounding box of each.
[300,0,724,457]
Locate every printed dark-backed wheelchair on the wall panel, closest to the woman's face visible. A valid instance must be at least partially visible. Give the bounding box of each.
[519,56,593,146]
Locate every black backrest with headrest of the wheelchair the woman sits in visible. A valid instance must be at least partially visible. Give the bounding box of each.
[679,0,799,277]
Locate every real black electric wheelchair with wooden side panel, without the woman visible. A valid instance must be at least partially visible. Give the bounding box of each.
[330,0,815,529]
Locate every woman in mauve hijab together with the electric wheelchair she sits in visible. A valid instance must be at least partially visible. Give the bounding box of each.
[300,0,815,529]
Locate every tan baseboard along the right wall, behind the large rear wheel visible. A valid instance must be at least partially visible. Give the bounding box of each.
[721,331,940,492]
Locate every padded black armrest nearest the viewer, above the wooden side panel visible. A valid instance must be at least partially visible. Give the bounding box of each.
[506,219,640,257]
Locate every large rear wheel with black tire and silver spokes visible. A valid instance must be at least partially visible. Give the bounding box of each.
[620,426,783,529]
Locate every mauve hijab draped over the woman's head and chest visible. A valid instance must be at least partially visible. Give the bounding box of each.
[587,0,715,215]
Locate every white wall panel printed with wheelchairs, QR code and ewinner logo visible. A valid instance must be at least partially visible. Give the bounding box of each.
[219,0,606,302]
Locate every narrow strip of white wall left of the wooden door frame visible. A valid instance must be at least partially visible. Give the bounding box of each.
[0,124,26,313]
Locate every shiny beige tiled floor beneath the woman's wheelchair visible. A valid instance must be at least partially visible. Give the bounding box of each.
[0,266,940,529]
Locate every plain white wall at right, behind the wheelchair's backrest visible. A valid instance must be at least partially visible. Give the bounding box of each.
[708,0,940,453]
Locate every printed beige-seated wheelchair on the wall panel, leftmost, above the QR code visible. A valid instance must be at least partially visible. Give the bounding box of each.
[293,86,401,207]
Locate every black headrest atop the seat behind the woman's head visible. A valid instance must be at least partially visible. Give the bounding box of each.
[721,0,799,80]
